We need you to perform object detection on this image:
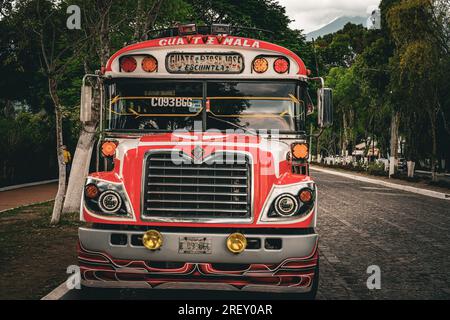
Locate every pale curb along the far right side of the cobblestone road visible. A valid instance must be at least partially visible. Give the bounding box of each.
[310,166,450,200]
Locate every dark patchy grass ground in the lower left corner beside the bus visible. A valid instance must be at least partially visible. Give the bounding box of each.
[0,202,80,300]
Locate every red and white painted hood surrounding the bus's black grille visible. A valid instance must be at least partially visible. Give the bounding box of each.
[86,133,311,228]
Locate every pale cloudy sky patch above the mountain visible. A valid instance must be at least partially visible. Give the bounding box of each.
[278,0,380,33]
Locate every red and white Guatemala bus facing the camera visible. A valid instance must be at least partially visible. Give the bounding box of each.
[78,25,332,296]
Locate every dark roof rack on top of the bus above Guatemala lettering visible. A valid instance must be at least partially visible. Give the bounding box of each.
[147,24,275,41]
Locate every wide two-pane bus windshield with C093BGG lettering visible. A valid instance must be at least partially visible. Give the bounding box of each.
[107,79,305,132]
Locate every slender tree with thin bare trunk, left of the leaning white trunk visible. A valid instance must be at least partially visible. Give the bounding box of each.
[16,0,83,224]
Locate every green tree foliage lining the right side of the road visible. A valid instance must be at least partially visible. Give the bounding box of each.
[316,0,450,172]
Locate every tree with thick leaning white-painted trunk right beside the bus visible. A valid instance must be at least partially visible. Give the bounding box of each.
[63,0,189,213]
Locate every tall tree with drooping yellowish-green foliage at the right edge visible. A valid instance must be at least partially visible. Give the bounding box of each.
[387,0,448,181]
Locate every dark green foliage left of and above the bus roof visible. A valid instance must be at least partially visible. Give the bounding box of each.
[0,0,313,184]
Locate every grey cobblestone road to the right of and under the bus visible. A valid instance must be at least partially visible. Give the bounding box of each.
[60,171,450,300]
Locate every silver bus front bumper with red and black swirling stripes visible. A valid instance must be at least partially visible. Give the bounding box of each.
[78,228,318,293]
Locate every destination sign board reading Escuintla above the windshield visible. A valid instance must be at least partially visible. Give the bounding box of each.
[166,52,244,74]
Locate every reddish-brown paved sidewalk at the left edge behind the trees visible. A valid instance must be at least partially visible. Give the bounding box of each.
[0,182,58,212]
